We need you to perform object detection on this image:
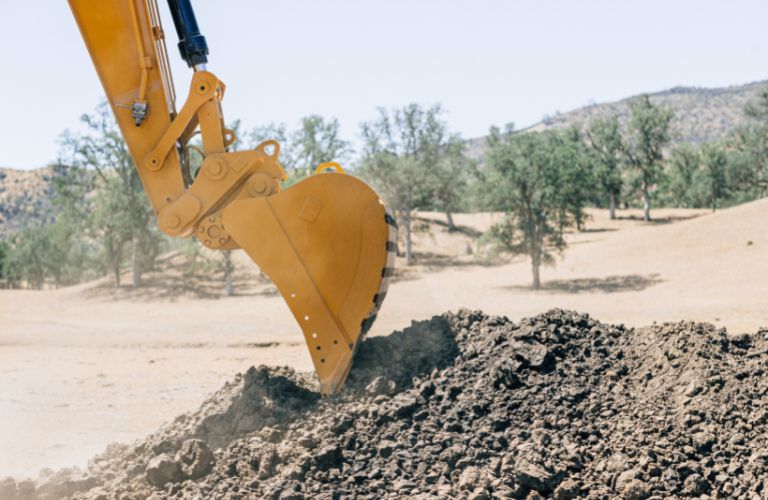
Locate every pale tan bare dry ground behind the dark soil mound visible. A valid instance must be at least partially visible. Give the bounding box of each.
[0,200,768,477]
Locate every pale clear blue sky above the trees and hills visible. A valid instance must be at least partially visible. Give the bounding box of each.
[0,0,768,168]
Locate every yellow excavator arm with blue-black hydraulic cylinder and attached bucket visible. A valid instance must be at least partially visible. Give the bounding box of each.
[69,0,397,396]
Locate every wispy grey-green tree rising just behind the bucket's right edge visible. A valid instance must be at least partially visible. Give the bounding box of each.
[359,104,455,265]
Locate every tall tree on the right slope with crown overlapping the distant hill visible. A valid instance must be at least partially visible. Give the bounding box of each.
[624,95,673,221]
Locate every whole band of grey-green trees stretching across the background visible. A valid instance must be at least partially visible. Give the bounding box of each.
[0,91,768,289]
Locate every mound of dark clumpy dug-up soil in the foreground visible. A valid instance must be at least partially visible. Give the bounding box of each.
[0,310,768,500]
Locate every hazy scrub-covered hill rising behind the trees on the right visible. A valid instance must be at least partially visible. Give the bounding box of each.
[469,81,768,161]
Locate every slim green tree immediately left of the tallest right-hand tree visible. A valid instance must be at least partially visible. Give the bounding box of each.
[586,116,624,220]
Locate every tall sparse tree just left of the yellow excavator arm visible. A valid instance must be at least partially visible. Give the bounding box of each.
[59,102,162,287]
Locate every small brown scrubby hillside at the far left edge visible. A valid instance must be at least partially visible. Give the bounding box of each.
[0,167,53,238]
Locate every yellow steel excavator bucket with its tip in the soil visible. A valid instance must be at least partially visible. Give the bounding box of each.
[223,169,397,395]
